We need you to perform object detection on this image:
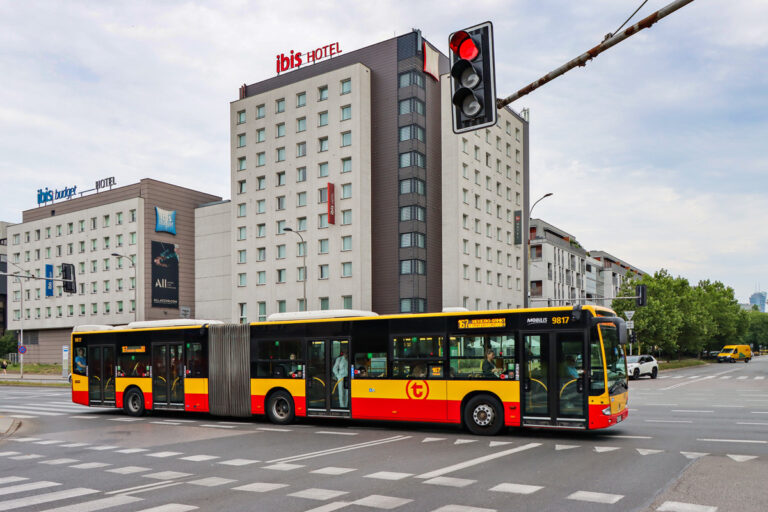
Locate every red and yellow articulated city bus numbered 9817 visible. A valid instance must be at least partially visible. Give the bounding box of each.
[72,306,627,435]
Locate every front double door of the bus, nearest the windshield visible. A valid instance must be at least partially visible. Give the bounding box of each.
[521,331,588,429]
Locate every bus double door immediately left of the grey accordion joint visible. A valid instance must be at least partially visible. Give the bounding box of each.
[152,343,184,408]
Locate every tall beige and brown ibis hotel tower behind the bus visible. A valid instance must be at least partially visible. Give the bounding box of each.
[206,31,528,322]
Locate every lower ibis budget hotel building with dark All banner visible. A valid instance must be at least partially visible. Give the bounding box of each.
[8,179,221,362]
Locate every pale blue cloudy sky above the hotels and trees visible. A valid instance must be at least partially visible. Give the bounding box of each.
[0,0,768,302]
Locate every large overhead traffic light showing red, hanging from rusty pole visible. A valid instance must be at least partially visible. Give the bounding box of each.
[448,21,496,133]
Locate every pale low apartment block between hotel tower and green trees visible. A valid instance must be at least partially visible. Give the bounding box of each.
[529,219,644,307]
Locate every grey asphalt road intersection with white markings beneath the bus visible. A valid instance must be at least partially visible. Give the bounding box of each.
[0,356,768,512]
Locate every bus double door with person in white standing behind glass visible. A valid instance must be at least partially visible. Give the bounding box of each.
[305,339,350,416]
